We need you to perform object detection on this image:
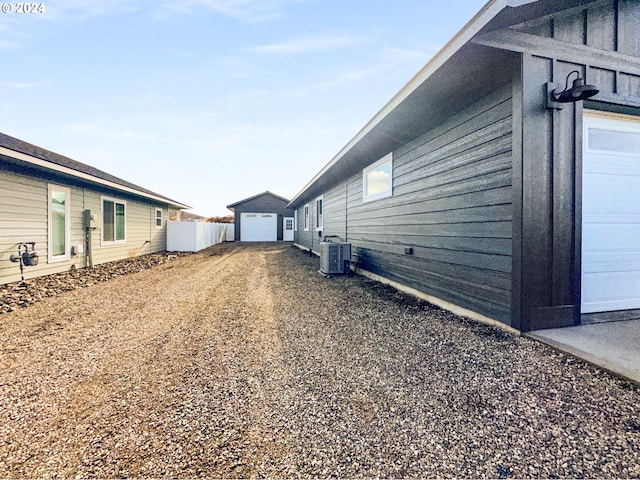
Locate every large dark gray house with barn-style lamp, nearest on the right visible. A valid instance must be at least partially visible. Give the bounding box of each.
[289,0,640,331]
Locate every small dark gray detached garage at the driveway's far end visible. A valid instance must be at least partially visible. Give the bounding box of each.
[227,191,294,242]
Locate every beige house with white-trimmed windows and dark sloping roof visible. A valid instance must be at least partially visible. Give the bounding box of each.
[0,133,190,284]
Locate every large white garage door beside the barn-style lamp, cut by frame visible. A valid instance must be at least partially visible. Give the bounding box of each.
[581,112,640,313]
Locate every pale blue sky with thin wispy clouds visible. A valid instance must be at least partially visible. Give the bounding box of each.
[0,0,485,216]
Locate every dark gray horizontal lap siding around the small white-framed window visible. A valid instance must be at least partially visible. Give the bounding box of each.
[344,85,513,323]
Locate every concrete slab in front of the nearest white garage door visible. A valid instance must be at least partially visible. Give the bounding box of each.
[526,320,640,384]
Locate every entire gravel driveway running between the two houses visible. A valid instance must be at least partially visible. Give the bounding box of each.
[0,244,640,478]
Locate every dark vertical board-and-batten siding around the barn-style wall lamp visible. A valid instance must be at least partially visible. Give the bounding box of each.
[514,0,640,331]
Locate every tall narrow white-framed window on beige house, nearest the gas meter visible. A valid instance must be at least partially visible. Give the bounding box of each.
[49,185,71,262]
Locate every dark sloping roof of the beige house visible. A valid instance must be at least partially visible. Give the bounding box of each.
[0,132,190,208]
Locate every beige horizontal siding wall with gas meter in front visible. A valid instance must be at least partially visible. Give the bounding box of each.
[0,164,168,284]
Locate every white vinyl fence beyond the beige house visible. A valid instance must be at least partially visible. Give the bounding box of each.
[167,222,234,252]
